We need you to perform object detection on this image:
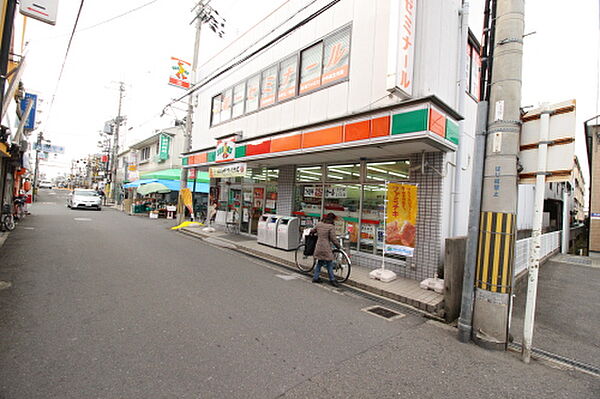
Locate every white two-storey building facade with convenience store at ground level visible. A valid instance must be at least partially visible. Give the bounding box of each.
[183,0,476,279]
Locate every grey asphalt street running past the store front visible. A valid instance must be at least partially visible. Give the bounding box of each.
[0,191,600,399]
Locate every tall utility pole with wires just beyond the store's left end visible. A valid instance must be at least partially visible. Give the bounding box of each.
[177,0,225,223]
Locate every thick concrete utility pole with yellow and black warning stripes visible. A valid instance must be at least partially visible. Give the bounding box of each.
[473,0,525,350]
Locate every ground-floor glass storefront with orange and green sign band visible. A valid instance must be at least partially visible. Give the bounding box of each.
[183,96,461,279]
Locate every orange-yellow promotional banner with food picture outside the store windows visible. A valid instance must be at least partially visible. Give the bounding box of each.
[385,183,419,256]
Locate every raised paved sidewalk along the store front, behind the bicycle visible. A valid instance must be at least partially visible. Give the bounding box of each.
[180,226,444,317]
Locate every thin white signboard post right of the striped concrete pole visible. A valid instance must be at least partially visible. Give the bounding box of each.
[522,104,551,363]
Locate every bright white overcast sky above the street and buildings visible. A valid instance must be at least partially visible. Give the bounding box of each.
[17,0,600,182]
